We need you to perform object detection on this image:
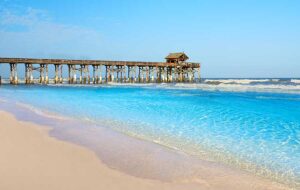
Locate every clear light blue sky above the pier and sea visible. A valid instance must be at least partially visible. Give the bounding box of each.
[0,0,300,78]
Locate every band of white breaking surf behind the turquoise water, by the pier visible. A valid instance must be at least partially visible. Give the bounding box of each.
[2,78,300,94]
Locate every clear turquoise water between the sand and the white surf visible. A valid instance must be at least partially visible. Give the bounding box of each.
[0,85,300,186]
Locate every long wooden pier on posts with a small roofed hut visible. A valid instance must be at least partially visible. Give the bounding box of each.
[0,53,200,85]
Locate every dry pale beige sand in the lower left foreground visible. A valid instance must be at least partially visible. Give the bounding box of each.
[0,111,286,190]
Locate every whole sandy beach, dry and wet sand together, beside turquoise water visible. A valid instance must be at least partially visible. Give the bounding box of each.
[0,111,288,190]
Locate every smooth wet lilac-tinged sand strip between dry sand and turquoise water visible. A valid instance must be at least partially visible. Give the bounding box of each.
[0,100,293,187]
